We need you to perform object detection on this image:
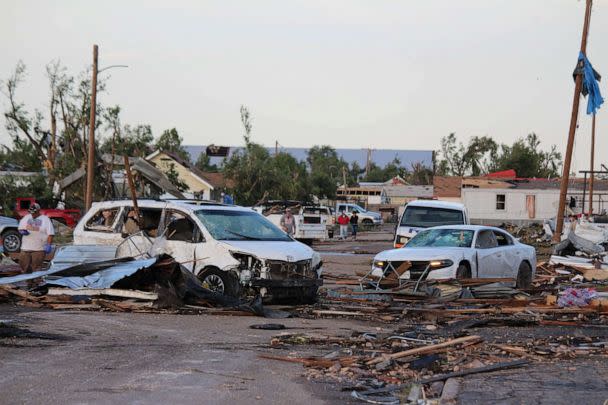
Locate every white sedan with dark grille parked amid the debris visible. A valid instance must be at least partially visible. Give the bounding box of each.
[371,225,536,288]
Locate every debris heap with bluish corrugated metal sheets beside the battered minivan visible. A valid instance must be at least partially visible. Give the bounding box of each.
[0,256,280,317]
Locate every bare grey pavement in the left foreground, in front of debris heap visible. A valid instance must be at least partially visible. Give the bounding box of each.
[0,305,372,404]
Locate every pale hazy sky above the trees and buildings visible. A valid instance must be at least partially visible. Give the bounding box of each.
[0,0,608,170]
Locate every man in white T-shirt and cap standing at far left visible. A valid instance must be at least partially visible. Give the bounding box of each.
[18,203,55,273]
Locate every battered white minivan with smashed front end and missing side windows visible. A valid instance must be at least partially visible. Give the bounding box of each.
[74,200,322,301]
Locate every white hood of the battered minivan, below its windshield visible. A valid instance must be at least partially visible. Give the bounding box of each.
[221,240,314,262]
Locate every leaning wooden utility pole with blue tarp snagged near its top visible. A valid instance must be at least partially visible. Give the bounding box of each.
[553,0,593,242]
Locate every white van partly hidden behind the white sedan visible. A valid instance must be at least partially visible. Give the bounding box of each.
[394,200,470,248]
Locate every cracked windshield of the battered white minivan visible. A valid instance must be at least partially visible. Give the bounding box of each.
[195,209,293,242]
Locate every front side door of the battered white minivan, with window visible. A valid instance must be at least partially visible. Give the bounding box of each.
[153,209,204,271]
